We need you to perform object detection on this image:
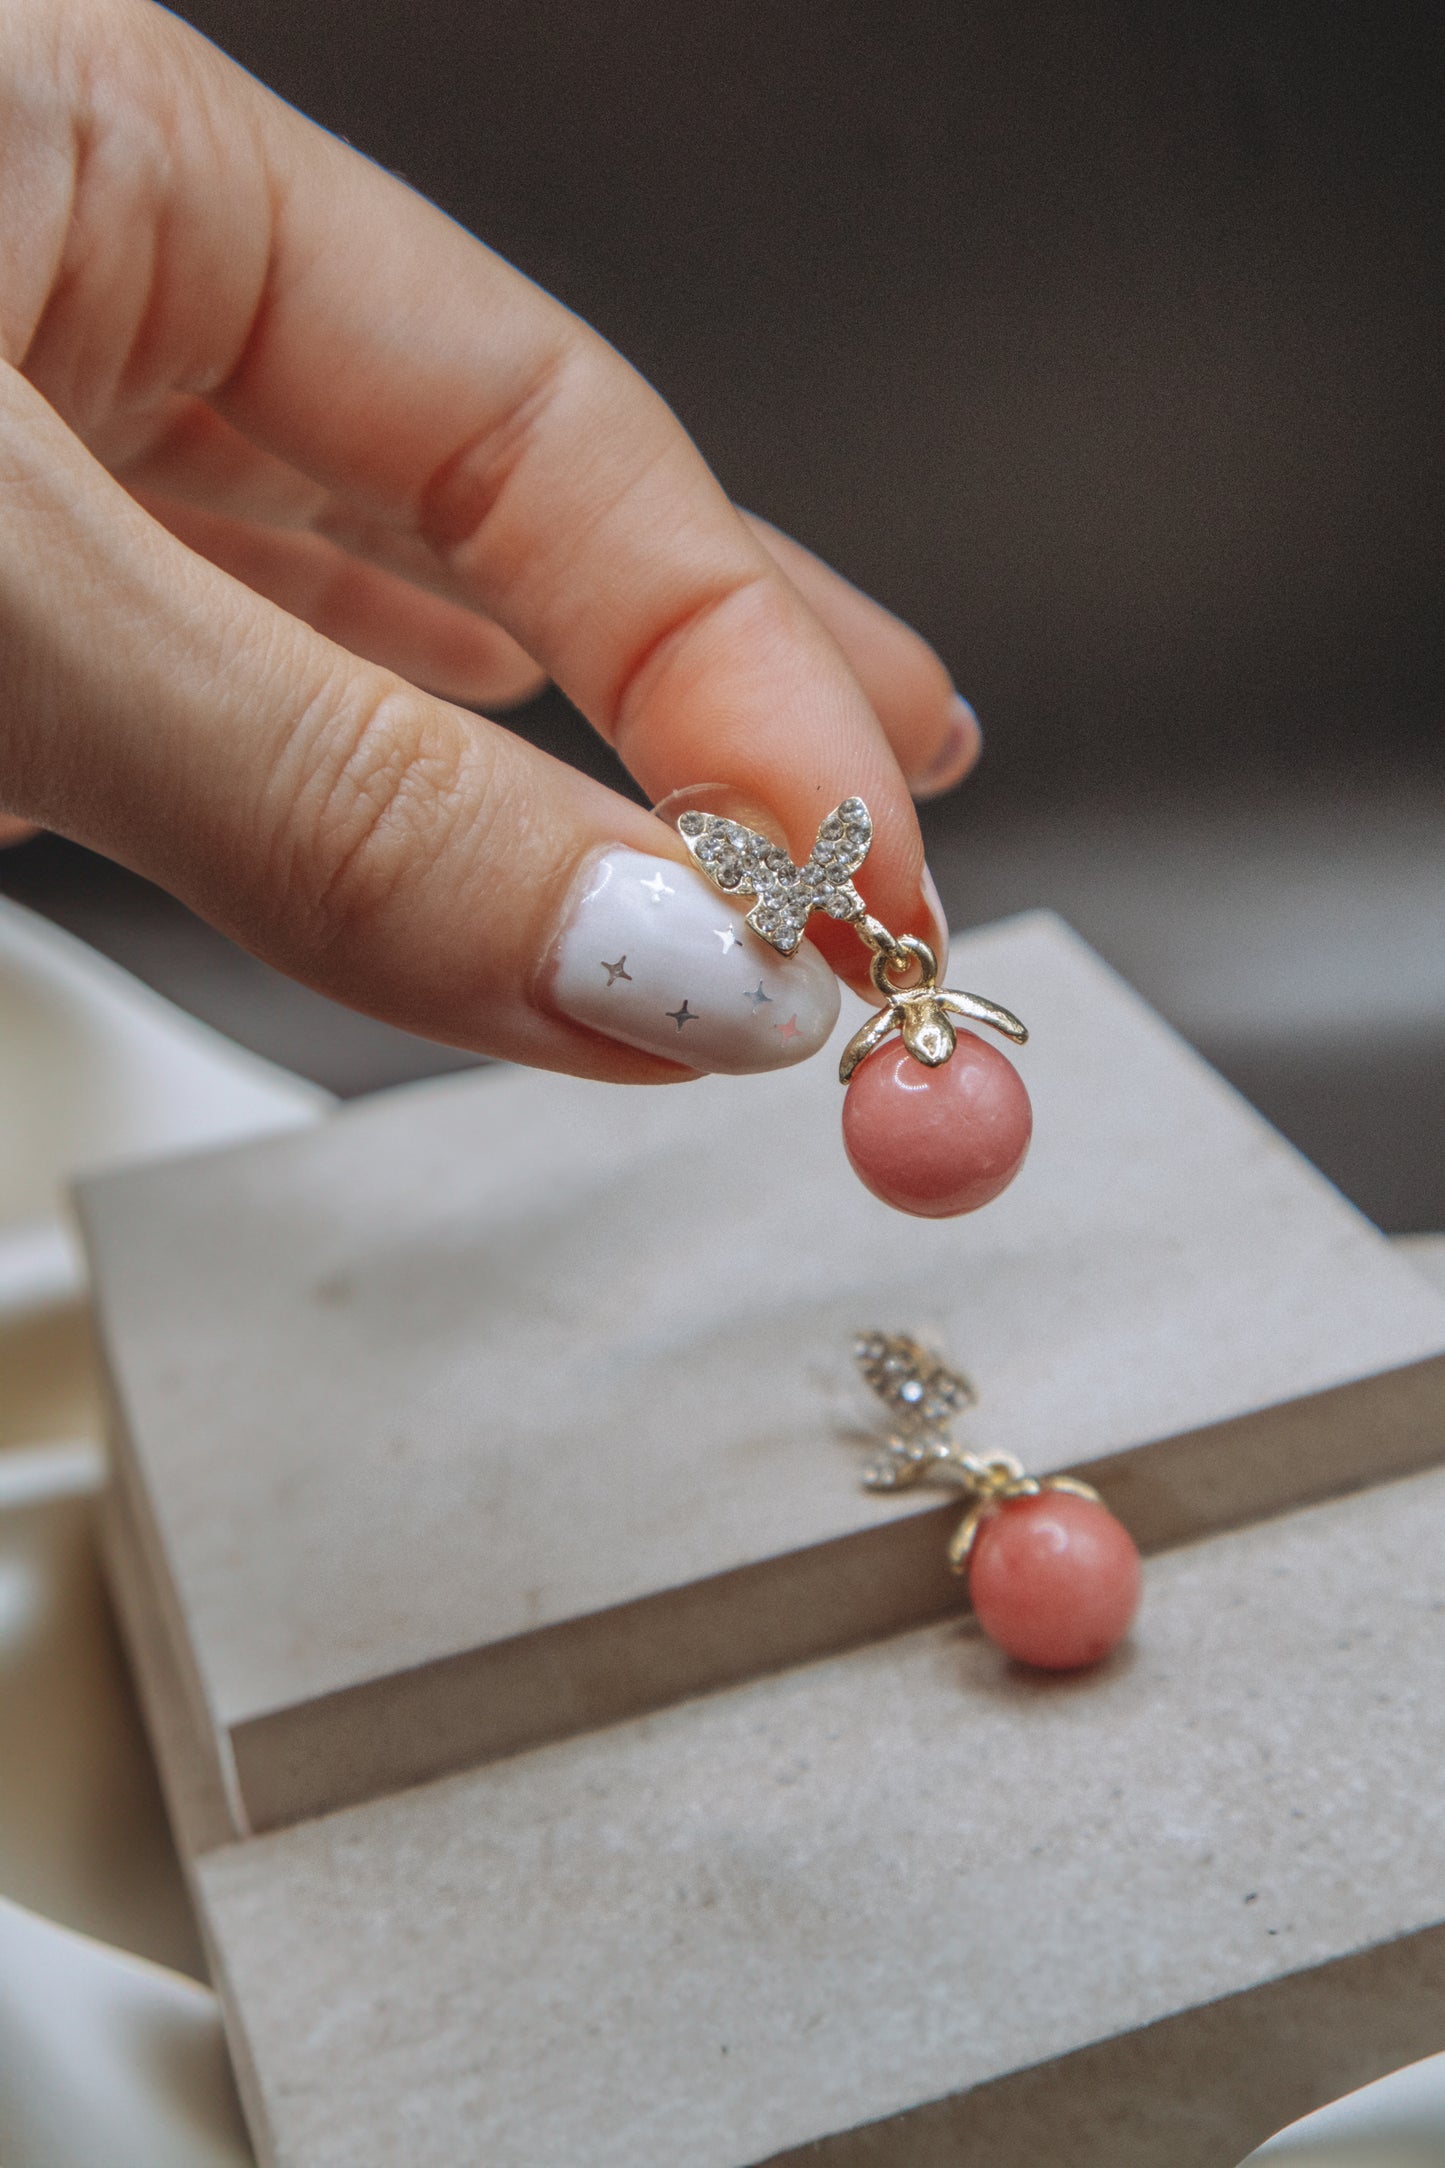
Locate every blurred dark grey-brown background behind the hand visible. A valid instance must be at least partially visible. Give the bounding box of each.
[0,0,1445,1229]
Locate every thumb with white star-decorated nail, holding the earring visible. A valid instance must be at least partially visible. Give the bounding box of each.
[0,369,838,1082]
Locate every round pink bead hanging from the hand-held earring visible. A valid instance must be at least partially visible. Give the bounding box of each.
[843,1032,1033,1218]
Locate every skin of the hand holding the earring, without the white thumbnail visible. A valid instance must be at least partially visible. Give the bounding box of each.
[0,0,977,1082]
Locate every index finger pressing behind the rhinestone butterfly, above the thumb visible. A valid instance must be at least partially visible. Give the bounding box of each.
[67,2,932,963]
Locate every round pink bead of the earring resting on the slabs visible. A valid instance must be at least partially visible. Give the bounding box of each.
[968,1492,1142,1672]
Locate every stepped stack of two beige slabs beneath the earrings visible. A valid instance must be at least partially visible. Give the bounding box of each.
[82,917,1445,2168]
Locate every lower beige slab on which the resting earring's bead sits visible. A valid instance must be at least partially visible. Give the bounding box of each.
[199,1472,1445,2168]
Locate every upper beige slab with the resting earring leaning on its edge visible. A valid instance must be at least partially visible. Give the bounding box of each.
[82,915,1445,1851]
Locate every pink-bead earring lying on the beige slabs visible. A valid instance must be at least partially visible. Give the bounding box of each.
[854,1333,1142,1672]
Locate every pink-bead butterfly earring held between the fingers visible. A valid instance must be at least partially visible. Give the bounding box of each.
[678,798,1033,1218]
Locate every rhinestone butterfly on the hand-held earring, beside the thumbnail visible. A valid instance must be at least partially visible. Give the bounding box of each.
[678,798,873,956]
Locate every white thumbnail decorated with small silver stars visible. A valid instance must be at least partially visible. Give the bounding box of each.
[550,846,838,1075]
